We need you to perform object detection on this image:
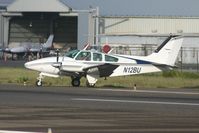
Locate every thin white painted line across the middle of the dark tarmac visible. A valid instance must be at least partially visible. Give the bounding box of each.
[71,98,199,106]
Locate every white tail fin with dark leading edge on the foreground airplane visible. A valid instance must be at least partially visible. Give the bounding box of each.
[147,35,183,66]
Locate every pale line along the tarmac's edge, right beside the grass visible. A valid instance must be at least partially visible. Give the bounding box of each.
[98,89,199,95]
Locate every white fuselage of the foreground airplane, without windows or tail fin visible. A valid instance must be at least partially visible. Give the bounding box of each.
[25,52,161,77]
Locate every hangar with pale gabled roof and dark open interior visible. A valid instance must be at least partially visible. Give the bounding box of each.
[0,0,78,48]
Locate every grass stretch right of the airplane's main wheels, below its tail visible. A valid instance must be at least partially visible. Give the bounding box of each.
[98,74,199,88]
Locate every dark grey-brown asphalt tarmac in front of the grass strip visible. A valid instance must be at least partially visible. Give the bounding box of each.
[0,85,199,133]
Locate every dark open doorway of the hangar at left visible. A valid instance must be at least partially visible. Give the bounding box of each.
[9,13,77,46]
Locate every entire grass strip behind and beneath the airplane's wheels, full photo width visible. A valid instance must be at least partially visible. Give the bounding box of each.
[0,68,199,88]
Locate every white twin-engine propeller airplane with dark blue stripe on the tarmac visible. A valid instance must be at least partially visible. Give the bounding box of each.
[25,35,183,87]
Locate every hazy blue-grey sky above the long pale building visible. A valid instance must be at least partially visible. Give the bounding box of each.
[0,0,199,17]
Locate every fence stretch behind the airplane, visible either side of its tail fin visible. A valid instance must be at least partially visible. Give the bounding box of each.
[112,45,199,72]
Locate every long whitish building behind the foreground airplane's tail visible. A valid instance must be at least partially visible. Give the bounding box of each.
[100,16,199,64]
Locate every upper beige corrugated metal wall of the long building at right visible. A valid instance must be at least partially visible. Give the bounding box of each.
[100,17,199,34]
